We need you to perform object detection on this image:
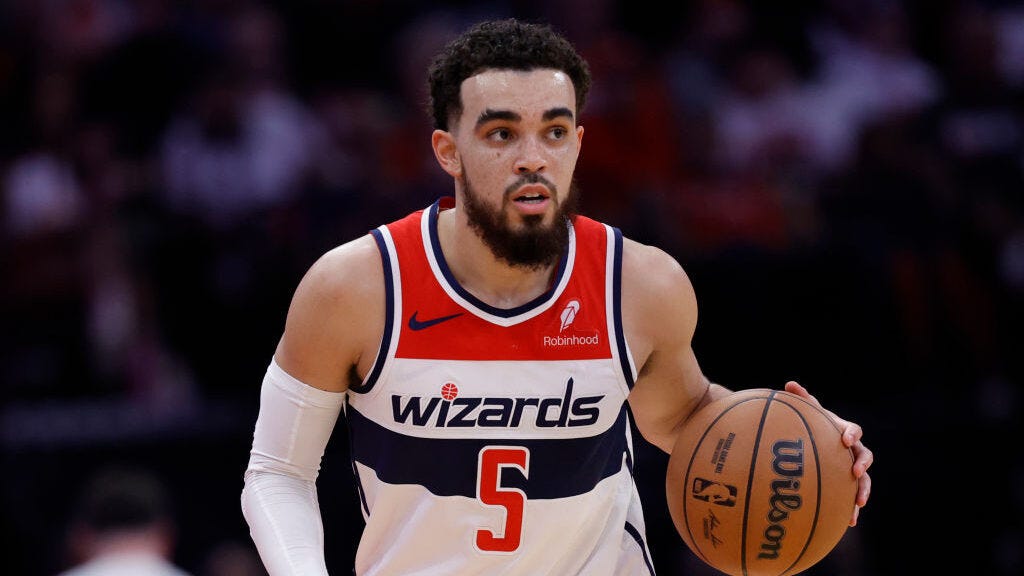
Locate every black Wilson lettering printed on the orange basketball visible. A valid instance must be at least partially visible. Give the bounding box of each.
[758,440,804,559]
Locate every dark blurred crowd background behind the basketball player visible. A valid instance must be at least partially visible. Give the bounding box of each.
[0,0,1024,576]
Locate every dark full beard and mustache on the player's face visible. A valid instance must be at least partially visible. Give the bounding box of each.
[461,167,580,270]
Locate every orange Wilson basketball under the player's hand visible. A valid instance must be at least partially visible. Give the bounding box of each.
[666,388,857,576]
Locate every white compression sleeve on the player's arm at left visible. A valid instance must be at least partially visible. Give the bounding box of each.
[242,360,345,576]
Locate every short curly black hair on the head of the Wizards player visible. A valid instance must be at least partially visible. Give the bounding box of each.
[427,18,591,130]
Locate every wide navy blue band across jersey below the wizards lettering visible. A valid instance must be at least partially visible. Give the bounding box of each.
[346,406,630,498]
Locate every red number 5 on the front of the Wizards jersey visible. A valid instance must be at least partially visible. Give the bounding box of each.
[476,446,529,552]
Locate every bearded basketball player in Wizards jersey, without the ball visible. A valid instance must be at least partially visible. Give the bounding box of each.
[242,19,872,576]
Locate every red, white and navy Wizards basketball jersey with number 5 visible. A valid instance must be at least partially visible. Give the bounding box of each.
[345,198,653,576]
